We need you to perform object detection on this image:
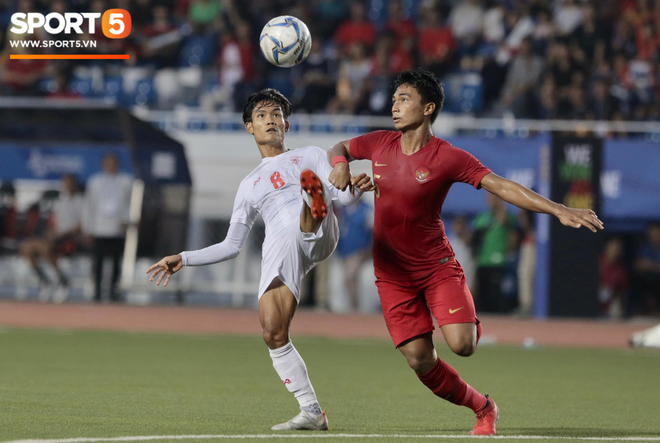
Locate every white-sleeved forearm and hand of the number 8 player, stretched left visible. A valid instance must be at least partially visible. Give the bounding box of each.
[146,223,250,286]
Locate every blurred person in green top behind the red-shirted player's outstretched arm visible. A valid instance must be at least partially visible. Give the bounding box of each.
[473,193,517,312]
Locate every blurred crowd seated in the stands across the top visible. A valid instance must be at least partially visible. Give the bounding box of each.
[0,0,660,121]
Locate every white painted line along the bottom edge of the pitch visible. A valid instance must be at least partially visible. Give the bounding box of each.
[1,434,660,443]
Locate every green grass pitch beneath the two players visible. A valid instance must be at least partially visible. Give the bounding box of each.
[0,329,660,442]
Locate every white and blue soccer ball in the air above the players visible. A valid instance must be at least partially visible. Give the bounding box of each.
[259,15,312,68]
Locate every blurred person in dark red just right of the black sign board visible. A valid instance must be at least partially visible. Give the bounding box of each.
[598,238,628,318]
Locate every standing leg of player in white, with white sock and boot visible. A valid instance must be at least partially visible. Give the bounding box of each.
[259,278,328,431]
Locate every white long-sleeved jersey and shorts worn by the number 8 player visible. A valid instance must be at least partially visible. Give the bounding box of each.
[181,146,361,299]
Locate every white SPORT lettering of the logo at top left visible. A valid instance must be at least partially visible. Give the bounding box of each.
[10,12,101,34]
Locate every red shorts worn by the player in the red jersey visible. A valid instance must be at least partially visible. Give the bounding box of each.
[376,258,479,347]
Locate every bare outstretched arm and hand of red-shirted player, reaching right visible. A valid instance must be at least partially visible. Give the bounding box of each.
[481,172,603,232]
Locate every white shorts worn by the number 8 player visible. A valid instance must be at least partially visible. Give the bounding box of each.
[259,212,339,302]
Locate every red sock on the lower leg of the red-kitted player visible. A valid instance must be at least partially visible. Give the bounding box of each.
[417,359,487,412]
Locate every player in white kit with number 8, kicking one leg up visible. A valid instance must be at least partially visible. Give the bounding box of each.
[147,89,373,430]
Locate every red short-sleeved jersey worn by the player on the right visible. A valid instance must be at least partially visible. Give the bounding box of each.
[350,131,491,282]
